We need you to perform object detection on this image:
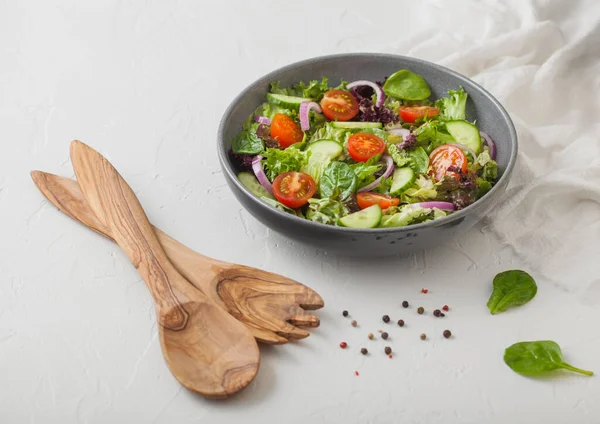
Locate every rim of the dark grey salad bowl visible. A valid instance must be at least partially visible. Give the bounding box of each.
[217,53,518,234]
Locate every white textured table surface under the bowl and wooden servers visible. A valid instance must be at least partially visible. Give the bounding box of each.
[0,0,600,424]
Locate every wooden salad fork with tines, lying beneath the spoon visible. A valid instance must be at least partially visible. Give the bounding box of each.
[31,171,323,344]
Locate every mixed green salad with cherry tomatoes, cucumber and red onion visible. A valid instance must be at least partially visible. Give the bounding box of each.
[230,69,498,228]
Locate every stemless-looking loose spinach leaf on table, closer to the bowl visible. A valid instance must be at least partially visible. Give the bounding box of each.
[487,270,537,315]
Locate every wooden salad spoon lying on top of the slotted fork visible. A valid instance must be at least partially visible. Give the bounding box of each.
[71,141,260,398]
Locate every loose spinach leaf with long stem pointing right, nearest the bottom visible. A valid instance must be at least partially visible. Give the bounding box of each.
[504,340,594,375]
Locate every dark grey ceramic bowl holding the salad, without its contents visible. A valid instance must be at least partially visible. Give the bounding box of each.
[218,54,517,256]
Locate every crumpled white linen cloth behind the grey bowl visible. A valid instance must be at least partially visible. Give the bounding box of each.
[388,0,600,294]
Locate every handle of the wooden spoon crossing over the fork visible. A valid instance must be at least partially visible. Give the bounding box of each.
[71,141,190,331]
